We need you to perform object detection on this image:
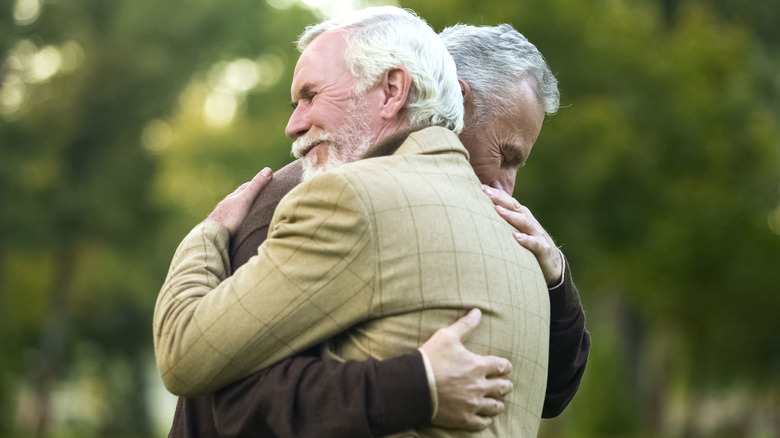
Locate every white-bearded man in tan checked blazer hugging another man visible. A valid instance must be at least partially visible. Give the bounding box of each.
[155,7,580,436]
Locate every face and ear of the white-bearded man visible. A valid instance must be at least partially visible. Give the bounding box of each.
[285,30,411,183]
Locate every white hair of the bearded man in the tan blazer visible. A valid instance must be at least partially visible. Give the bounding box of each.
[298,6,463,133]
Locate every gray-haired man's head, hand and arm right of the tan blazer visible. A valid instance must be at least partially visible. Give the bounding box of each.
[440,24,590,418]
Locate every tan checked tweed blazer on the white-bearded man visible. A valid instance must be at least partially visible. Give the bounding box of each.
[154,127,549,437]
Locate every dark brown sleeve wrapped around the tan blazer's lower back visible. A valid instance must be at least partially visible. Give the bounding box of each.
[214,351,432,438]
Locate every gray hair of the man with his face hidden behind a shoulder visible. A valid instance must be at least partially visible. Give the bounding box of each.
[439,24,560,124]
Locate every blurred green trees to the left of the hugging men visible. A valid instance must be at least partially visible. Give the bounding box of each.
[0,0,314,436]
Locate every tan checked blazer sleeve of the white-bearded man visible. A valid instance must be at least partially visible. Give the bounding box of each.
[153,174,375,396]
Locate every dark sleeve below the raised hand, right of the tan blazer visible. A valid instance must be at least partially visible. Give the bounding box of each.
[542,258,590,418]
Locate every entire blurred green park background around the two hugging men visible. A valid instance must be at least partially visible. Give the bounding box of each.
[0,0,780,438]
